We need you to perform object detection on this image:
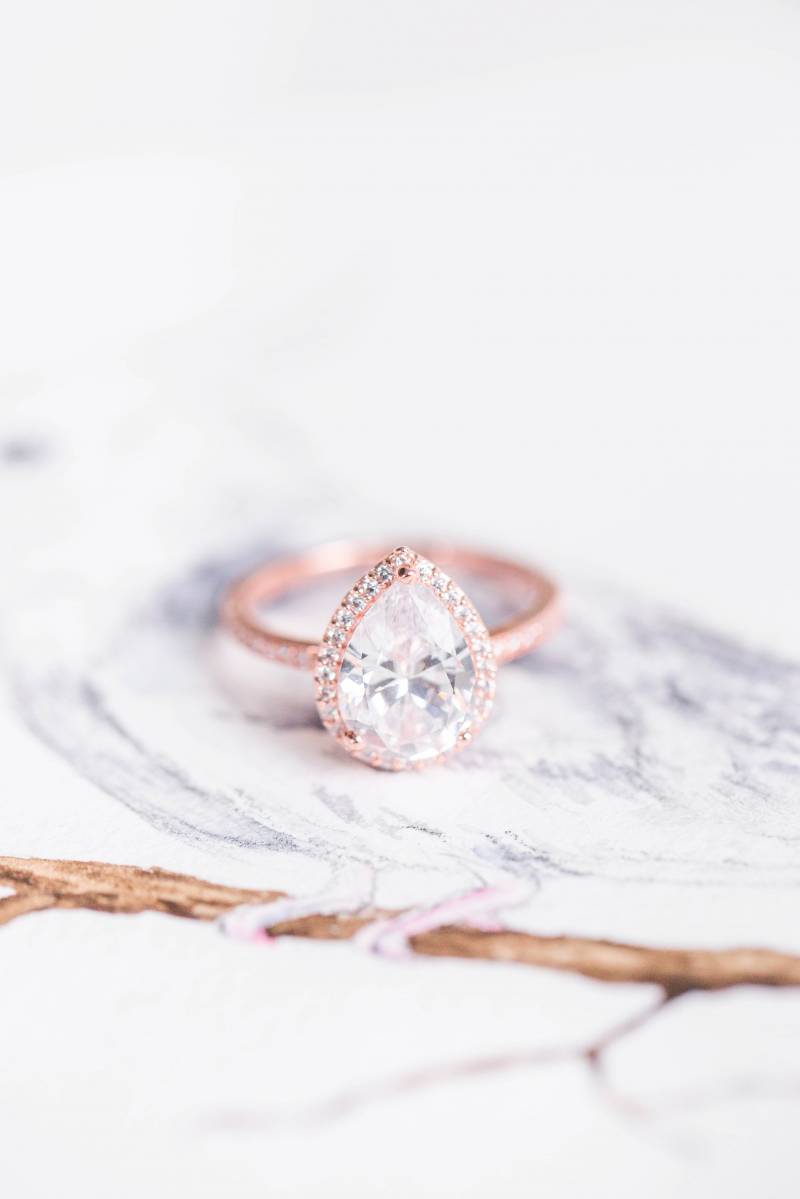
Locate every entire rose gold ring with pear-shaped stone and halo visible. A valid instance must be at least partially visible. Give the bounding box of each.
[223,543,558,770]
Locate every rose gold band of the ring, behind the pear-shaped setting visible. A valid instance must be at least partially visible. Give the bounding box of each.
[222,541,560,670]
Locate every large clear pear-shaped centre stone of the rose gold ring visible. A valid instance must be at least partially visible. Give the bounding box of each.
[338,582,476,766]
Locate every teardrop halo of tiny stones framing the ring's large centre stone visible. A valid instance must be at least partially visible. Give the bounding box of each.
[314,546,497,771]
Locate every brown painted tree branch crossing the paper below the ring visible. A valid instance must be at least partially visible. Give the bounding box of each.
[0,857,800,996]
